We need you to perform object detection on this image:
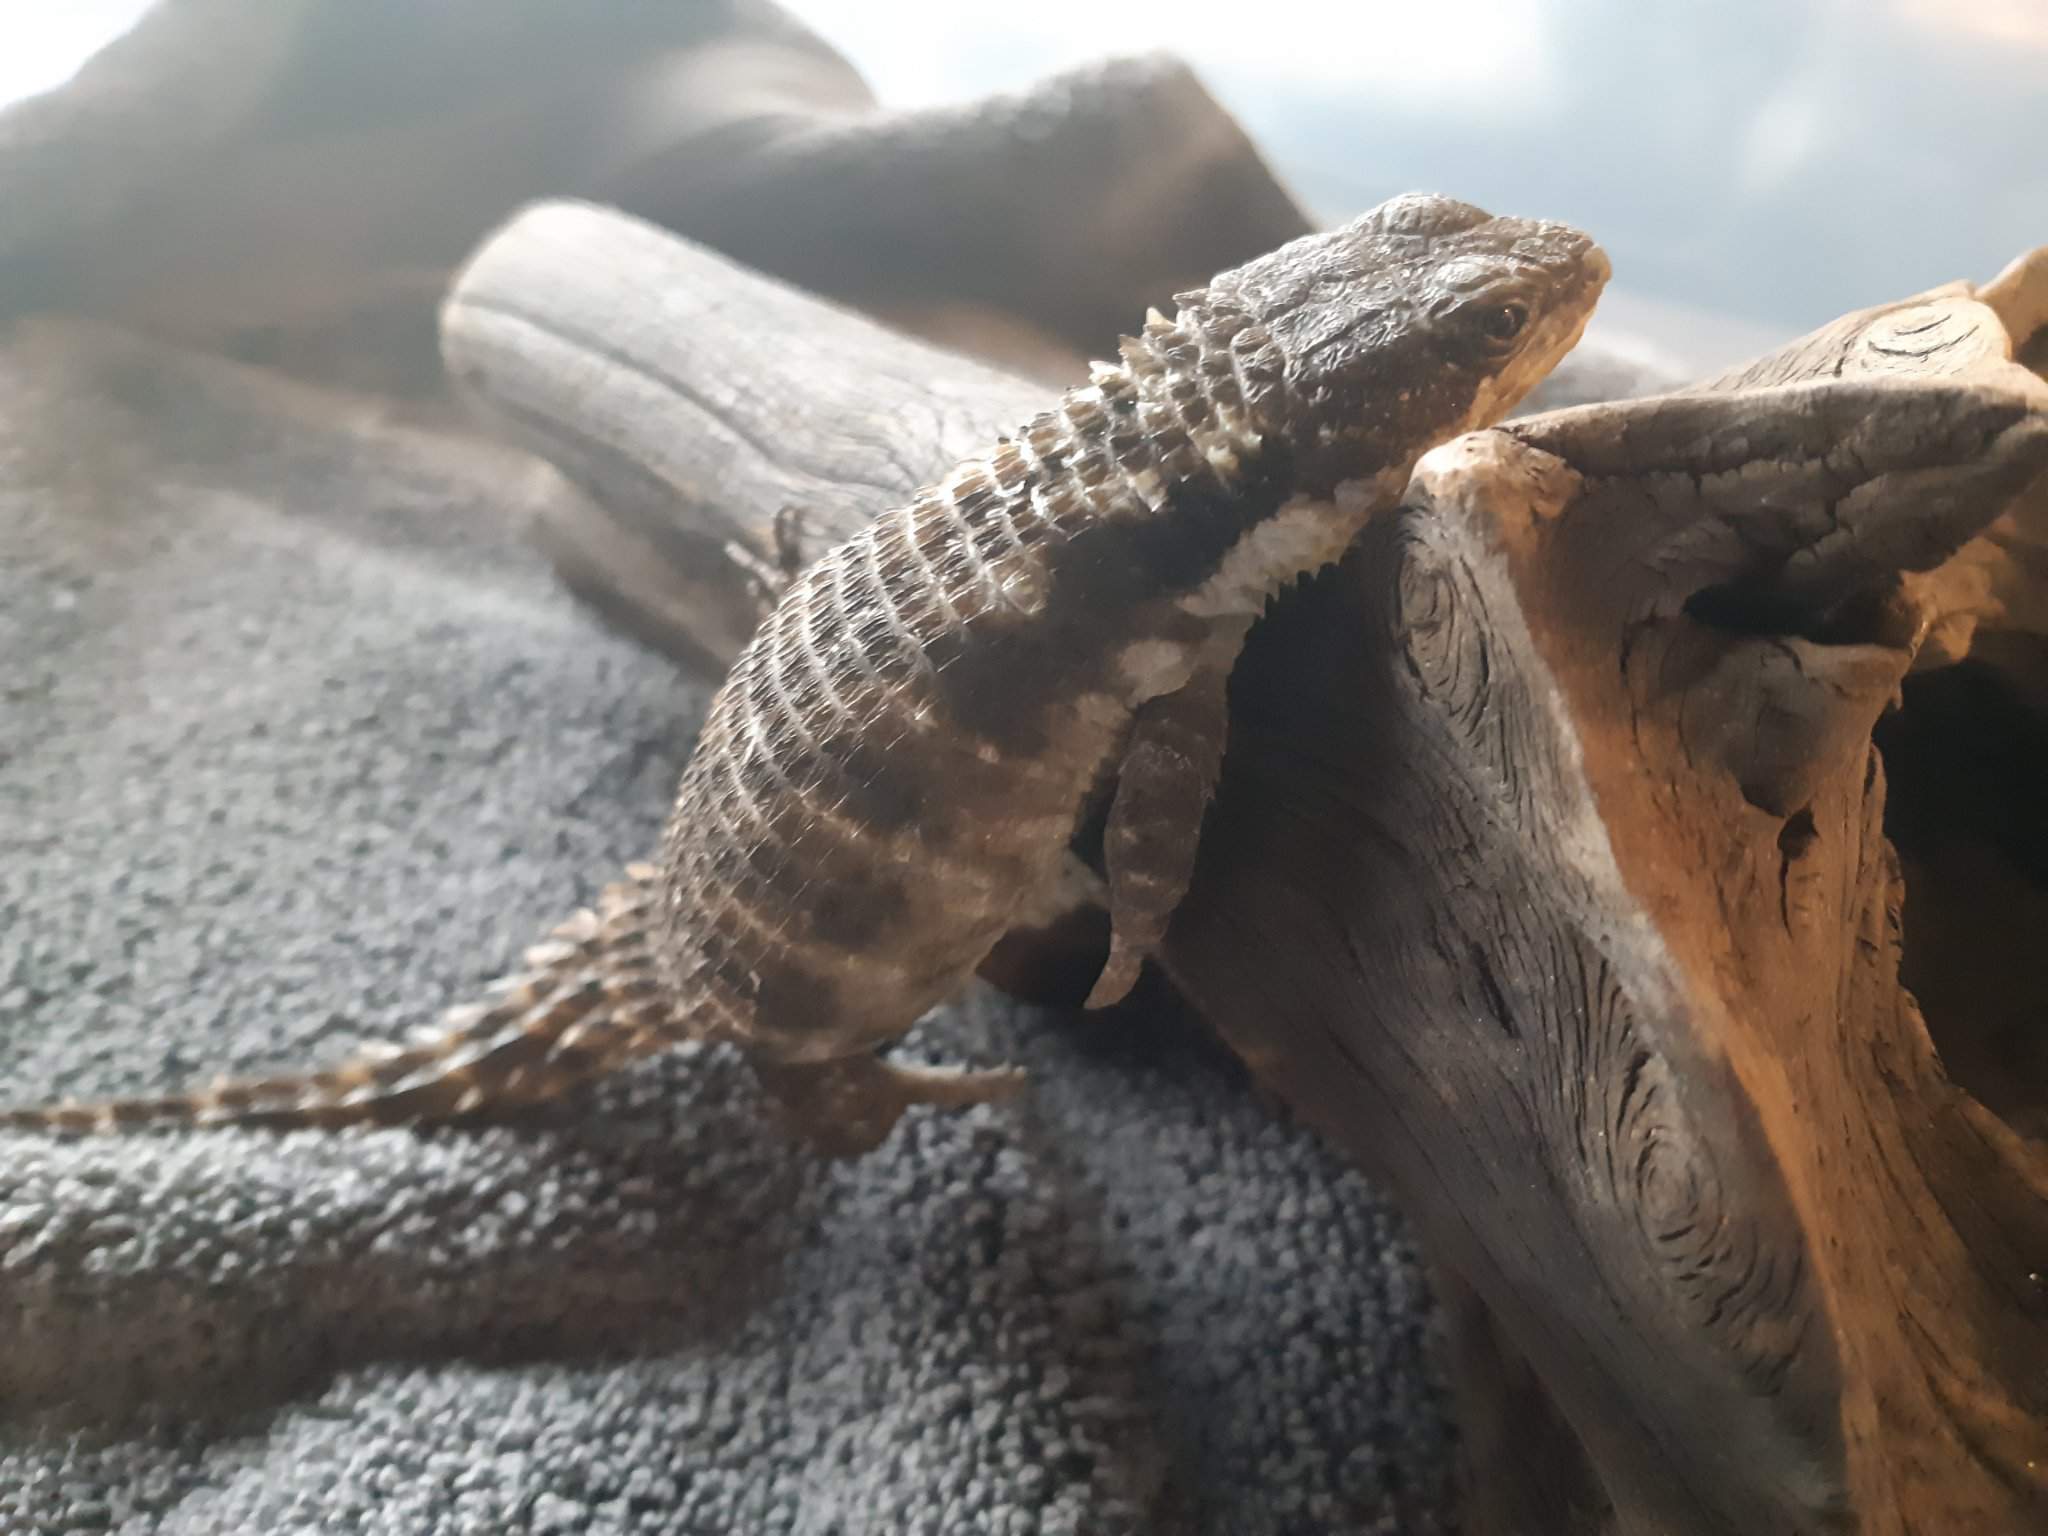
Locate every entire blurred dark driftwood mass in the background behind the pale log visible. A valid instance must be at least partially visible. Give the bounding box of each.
[0,0,1307,395]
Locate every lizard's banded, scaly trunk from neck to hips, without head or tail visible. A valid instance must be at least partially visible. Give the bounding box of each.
[664,303,1292,1061]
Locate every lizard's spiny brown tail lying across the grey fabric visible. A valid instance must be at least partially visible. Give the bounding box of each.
[0,864,684,1135]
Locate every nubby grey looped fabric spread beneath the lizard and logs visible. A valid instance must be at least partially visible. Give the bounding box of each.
[0,319,1450,1536]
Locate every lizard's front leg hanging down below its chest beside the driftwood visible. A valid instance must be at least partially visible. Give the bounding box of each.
[1085,645,1237,1008]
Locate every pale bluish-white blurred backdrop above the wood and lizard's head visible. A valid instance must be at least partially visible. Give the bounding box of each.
[0,0,2048,370]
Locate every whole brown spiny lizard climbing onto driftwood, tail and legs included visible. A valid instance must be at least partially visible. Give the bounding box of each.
[0,195,1608,1151]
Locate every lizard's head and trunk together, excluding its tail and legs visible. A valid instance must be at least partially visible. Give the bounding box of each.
[662,197,1606,1061]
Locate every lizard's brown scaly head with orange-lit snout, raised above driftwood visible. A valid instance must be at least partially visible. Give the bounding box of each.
[1190,195,1612,494]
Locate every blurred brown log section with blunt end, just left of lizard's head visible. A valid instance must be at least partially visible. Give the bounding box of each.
[604,55,1309,366]
